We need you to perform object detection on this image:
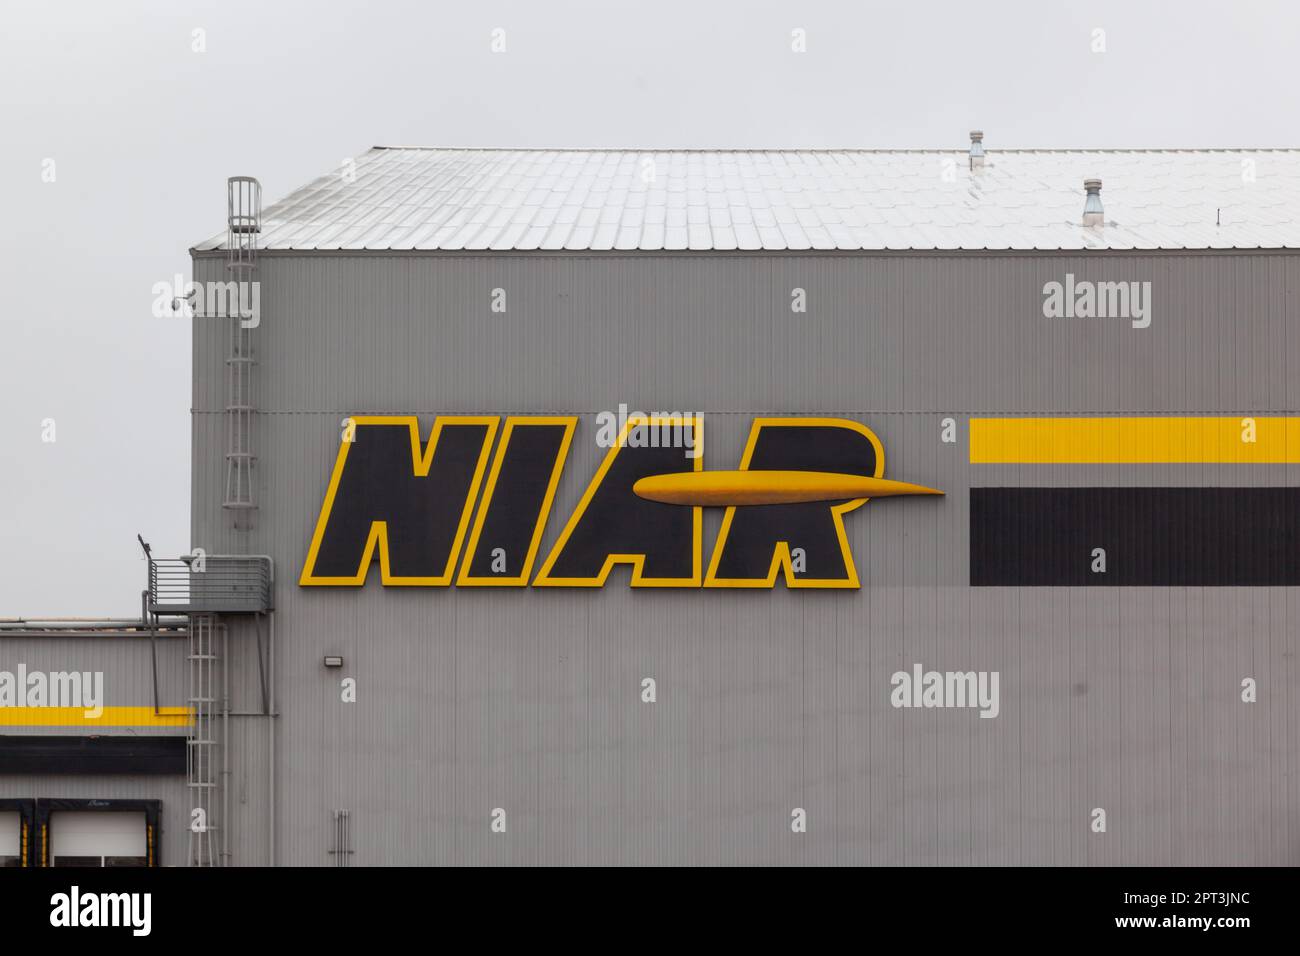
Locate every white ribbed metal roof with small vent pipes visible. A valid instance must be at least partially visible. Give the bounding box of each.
[195,147,1300,251]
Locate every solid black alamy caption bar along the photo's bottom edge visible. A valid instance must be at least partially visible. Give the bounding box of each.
[0,866,1279,952]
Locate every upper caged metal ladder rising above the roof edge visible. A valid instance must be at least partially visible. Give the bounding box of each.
[221,176,261,528]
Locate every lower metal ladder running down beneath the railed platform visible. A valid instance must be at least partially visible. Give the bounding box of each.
[186,614,224,866]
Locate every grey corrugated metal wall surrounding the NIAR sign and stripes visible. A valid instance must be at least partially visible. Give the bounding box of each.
[32,254,1300,865]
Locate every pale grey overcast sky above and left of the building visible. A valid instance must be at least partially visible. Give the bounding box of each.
[0,0,1300,617]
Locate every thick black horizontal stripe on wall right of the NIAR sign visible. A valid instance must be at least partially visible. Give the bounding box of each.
[970,488,1300,588]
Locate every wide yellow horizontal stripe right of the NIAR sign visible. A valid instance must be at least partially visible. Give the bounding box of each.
[971,416,1300,464]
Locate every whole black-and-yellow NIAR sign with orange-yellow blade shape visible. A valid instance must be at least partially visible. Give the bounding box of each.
[299,415,943,588]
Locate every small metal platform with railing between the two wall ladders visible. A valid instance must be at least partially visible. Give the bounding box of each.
[148,554,274,614]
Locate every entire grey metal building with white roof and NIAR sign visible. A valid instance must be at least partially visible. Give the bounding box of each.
[0,138,1300,865]
